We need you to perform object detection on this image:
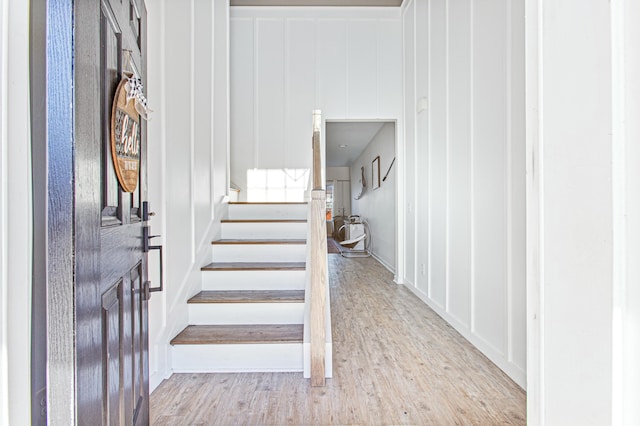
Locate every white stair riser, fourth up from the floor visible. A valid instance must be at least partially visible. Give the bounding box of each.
[213,244,307,262]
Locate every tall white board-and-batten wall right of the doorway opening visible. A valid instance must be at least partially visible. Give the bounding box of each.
[399,0,526,387]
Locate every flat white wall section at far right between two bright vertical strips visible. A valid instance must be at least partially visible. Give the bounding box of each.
[540,0,613,425]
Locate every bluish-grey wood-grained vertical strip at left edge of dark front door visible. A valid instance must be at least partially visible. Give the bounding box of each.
[39,0,78,424]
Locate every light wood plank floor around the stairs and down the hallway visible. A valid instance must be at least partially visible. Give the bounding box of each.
[151,255,526,425]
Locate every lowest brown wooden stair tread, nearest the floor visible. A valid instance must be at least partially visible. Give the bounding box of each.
[171,324,304,345]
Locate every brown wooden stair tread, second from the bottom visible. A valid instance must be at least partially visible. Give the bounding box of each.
[187,290,304,303]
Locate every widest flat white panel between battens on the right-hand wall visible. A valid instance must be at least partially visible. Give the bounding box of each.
[472,1,510,356]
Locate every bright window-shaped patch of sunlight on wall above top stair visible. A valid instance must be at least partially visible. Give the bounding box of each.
[247,169,309,202]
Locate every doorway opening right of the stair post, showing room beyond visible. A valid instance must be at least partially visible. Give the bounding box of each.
[324,119,397,273]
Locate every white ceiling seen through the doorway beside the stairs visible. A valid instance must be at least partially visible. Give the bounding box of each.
[325,121,384,167]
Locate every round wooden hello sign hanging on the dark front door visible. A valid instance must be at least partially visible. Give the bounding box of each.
[111,77,140,192]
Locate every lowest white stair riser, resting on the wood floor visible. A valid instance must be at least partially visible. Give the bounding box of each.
[171,343,303,373]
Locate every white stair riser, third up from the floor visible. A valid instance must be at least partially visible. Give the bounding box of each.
[202,271,306,290]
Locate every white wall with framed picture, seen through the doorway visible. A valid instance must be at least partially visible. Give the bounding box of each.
[350,123,396,273]
